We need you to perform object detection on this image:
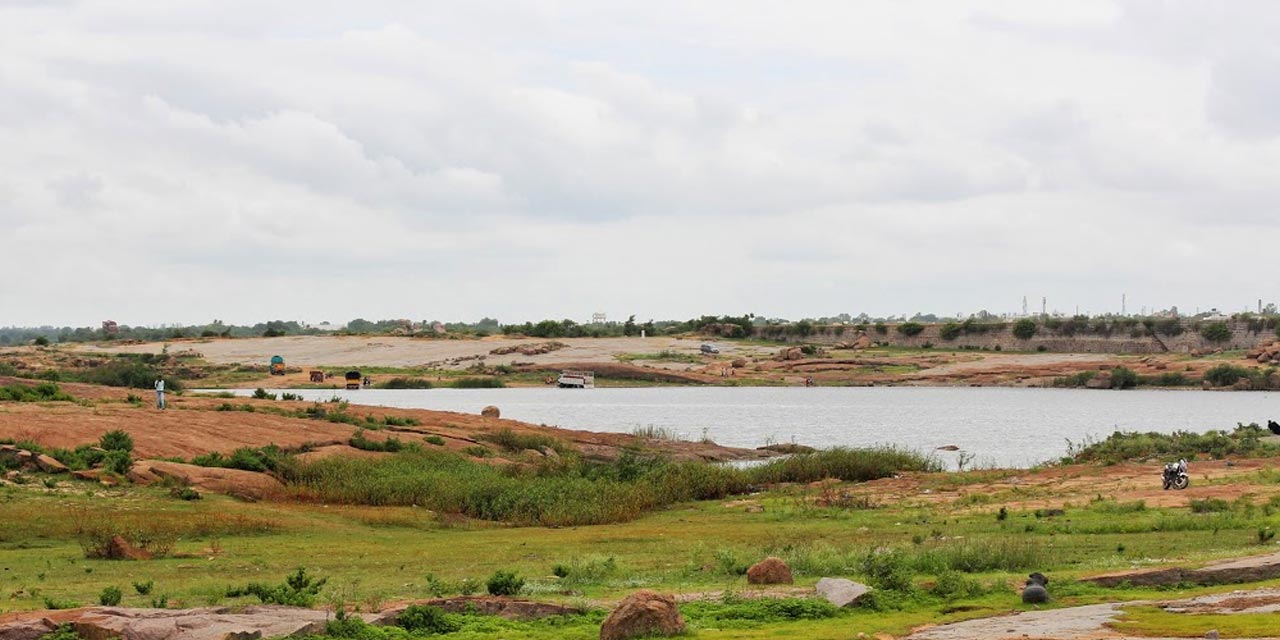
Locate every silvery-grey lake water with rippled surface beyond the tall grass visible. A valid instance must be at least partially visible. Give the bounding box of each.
[212,387,1280,467]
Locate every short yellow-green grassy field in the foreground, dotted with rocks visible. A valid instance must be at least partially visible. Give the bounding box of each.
[0,455,1280,637]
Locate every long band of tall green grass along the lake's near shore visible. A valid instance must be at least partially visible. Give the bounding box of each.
[280,445,937,526]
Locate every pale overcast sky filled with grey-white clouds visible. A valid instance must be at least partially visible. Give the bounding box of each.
[0,0,1280,326]
